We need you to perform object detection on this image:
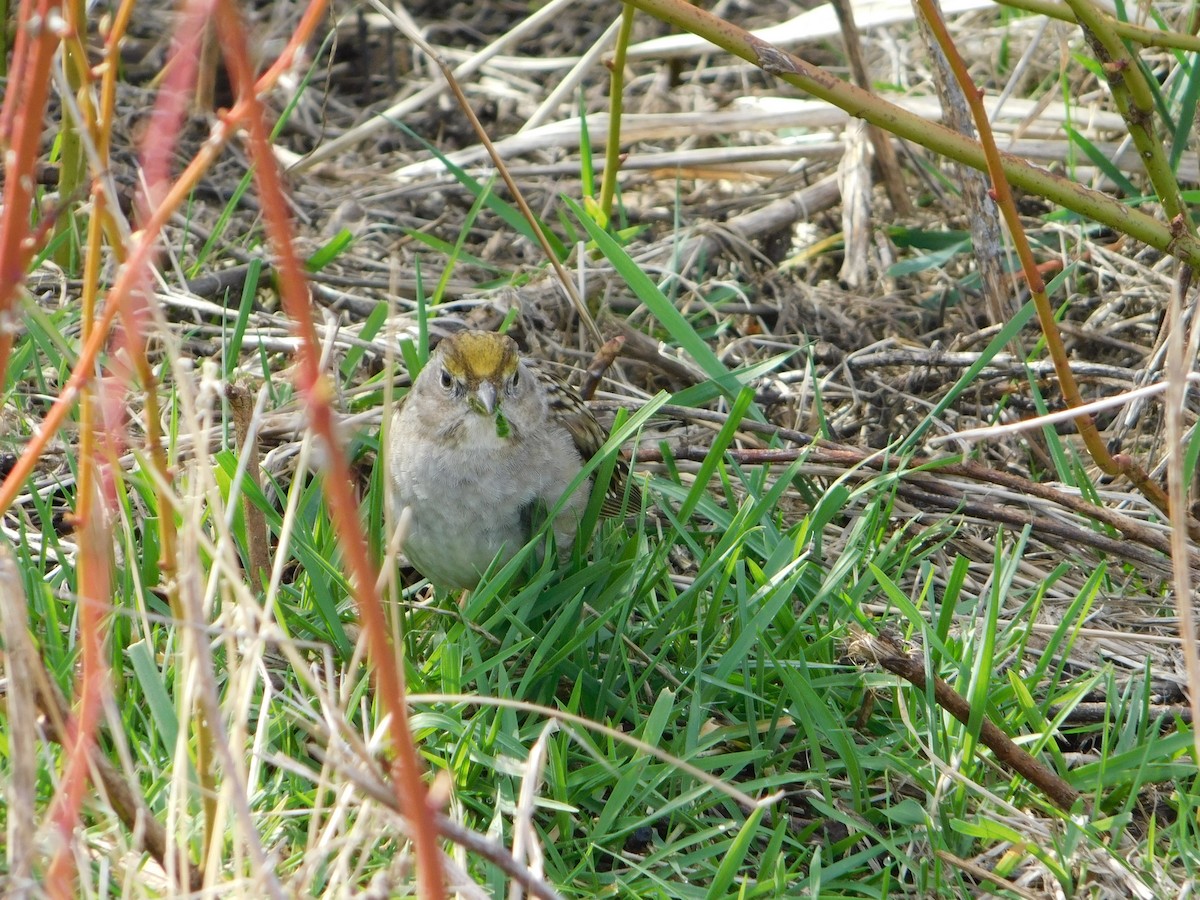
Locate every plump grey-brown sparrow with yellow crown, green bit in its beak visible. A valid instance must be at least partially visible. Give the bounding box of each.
[390,331,640,589]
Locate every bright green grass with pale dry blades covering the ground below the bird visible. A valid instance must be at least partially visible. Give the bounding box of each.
[0,307,1194,898]
